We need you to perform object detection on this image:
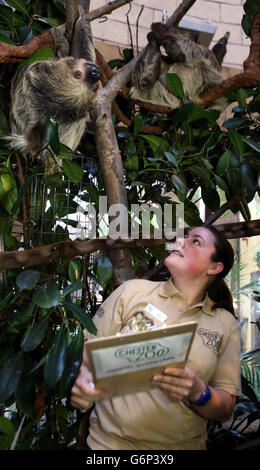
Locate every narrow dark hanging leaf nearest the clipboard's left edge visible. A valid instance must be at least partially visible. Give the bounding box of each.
[58,329,84,398]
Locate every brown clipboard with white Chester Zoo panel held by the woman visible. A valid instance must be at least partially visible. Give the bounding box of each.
[85,322,198,397]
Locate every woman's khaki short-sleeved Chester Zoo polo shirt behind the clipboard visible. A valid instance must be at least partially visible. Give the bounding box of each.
[87,279,240,450]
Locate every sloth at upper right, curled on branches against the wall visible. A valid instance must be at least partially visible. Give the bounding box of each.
[130,23,227,111]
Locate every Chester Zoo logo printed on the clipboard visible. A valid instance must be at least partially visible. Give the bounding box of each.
[115,343,170,362]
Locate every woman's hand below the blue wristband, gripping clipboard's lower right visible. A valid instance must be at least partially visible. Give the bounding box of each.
[152,367,206,401]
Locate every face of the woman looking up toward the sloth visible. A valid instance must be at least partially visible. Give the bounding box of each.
[165,227,223,278]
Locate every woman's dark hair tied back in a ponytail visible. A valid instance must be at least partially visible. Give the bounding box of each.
[205,226,235,317]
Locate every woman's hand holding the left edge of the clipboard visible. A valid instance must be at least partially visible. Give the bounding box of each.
[71,348,106,411]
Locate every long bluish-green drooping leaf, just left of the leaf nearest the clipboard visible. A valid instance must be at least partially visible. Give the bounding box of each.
[44,326,68,389]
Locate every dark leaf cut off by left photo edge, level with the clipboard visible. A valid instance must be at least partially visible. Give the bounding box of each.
[0,351,23,402]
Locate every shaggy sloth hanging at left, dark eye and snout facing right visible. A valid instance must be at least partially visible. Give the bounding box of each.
[6,57,101,156]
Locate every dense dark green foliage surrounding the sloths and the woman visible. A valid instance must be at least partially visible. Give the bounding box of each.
[0,0,260,449]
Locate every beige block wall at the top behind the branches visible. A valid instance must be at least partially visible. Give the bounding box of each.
[91,0,250,69]
